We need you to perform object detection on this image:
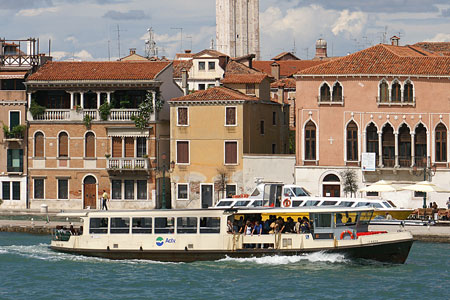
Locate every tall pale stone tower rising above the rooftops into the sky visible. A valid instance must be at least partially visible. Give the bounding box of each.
[216,0,260,59]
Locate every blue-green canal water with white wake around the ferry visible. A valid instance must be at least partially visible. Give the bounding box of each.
[0,233,450,300]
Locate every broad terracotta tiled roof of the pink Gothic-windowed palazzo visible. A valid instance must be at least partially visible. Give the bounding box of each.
[298,44,450,76]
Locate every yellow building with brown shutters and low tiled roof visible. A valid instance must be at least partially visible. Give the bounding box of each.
[169,87,288,208]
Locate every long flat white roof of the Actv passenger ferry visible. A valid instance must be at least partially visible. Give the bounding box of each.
[57,206,374,217]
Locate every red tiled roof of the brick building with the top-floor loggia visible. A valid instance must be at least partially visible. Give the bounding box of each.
[28,61,170,81]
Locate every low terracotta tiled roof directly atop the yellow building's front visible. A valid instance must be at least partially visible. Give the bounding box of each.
[169,86,259,102]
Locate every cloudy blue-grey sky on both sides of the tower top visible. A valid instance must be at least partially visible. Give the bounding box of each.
[0,0,450,60]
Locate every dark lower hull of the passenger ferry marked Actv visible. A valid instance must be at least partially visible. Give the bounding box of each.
[51,239,413,264]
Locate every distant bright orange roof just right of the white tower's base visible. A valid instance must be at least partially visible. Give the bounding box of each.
[253,60,325,77]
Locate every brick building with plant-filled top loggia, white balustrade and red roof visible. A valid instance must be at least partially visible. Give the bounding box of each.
[26,61,182,209]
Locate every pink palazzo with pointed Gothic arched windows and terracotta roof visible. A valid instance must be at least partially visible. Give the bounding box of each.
[295,43,450,208]
